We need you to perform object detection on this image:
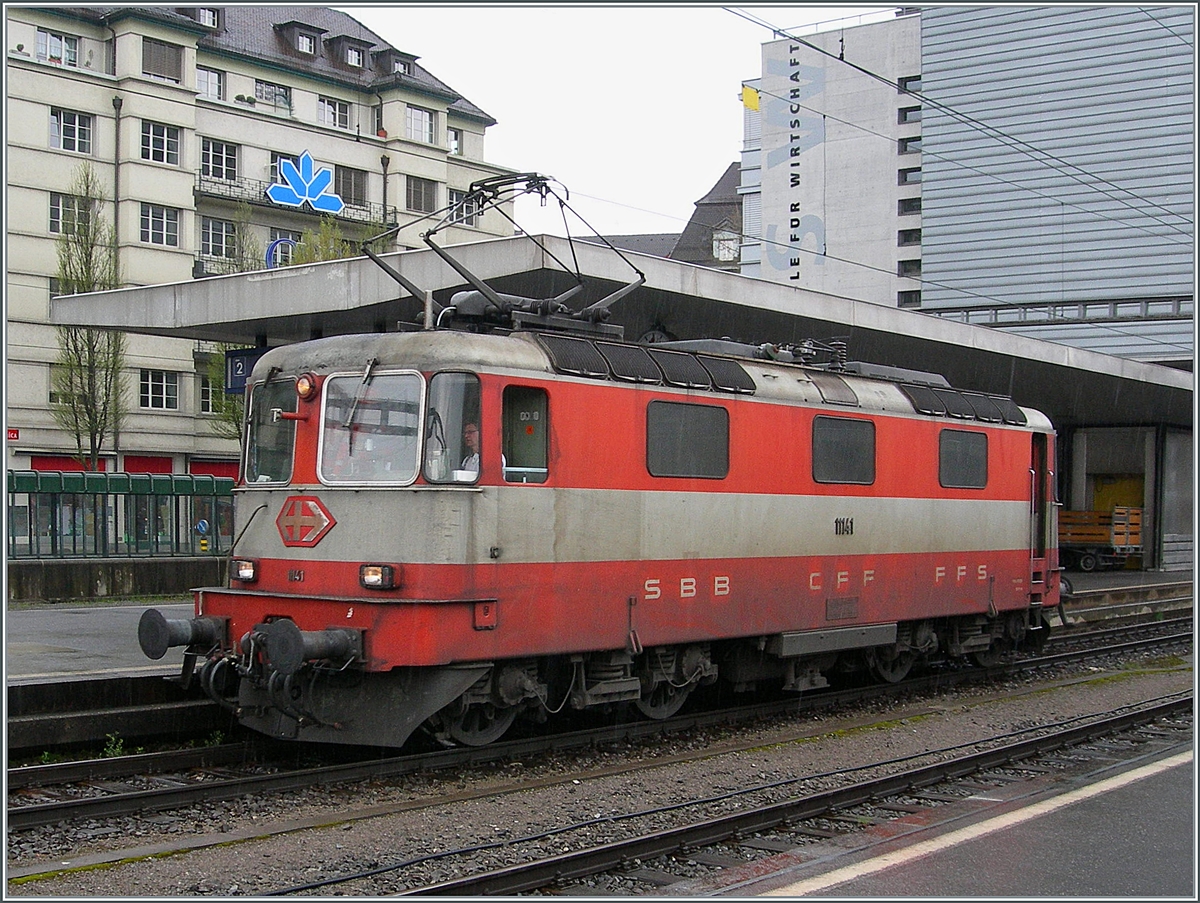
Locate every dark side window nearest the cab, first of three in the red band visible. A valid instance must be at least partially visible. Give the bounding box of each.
[646,401,730,479]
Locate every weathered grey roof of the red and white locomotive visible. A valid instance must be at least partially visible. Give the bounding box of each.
[252,330,1051,430]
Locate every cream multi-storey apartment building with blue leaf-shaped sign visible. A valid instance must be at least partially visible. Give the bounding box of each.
[5,6,512,474]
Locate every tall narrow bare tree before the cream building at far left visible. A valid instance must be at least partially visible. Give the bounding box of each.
[50,163,127,471]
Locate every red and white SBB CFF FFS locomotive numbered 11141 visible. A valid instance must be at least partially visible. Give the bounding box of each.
[139,176,1058,746]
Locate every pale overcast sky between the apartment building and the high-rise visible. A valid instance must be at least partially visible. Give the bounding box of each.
[338,4,894,234]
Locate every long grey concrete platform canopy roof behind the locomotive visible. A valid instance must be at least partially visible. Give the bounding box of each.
[50,235,1193,430]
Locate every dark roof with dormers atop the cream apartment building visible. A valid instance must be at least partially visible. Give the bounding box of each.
[47,5,496,126]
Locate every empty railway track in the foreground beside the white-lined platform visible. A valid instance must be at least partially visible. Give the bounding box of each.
[372,692,1193,896]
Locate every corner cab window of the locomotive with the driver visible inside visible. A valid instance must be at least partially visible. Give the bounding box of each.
[425,372,480,483]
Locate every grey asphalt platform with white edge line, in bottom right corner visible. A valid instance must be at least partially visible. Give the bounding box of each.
[718,748,1196,899]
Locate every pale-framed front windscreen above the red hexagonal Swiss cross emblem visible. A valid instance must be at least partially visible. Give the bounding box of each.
[319,372,424,483]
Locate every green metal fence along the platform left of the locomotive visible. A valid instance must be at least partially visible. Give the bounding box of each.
[8,471,234,558]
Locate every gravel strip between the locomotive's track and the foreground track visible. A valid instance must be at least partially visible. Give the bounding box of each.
[6,656,1193,897]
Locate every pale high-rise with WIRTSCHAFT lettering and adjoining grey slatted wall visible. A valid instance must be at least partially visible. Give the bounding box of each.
[742,5,1195,369]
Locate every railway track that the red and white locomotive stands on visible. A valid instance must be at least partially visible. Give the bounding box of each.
[7,629,1192,831]
